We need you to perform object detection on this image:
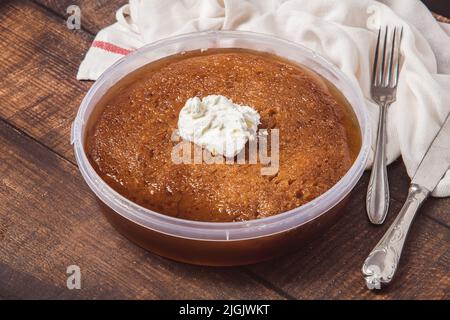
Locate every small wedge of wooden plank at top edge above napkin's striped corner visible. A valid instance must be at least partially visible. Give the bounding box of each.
[35,0,128,34]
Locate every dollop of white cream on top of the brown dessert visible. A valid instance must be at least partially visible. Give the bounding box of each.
[178,95,260,157]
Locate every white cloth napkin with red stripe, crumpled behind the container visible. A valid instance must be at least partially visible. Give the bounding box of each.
[77,0,450,197]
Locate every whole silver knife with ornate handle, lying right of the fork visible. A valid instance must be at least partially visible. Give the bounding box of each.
[362,115,450,289]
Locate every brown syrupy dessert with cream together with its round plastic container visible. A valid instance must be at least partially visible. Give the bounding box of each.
[72,31,369,265]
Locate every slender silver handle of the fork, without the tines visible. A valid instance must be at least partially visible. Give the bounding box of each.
[366,103,389,224]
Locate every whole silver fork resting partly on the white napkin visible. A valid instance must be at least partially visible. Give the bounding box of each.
[366,26,403,224]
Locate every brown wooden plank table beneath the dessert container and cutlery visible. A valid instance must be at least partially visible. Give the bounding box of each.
[0,0,450,299]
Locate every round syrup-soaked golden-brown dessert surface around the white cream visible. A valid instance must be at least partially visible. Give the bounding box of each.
[85,49,360,222]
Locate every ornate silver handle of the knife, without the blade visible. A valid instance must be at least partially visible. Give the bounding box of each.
[362,184,430,289]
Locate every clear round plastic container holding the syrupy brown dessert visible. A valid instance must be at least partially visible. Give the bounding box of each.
[71,31,370,266]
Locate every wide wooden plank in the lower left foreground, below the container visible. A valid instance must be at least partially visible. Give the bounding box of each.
[0,122,281,299]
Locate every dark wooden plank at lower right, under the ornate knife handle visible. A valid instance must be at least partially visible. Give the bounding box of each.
[251,180,450,299]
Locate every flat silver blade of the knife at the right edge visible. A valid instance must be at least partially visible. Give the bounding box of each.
[411,114,450,192]
